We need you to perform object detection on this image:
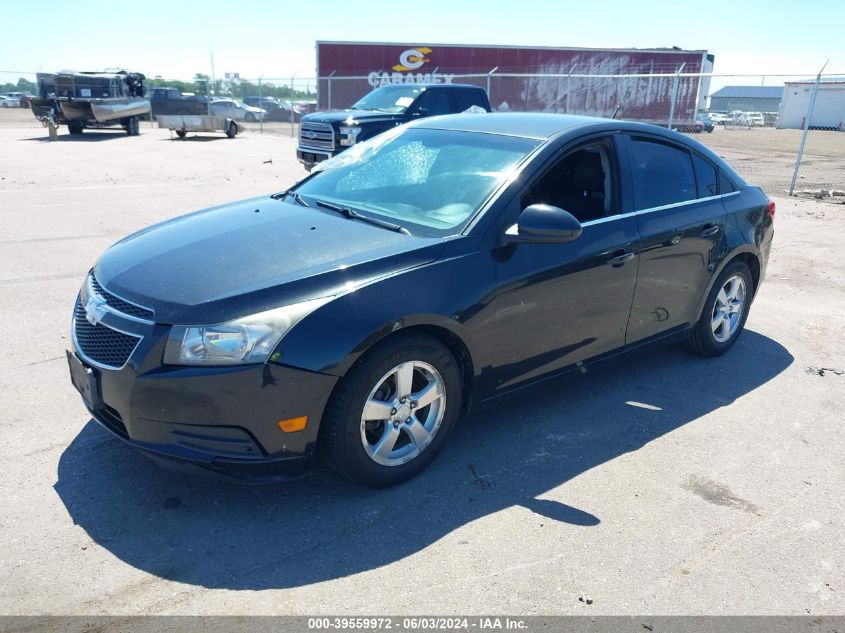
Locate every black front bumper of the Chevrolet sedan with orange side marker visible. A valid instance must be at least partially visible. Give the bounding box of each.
[68,292,338,478]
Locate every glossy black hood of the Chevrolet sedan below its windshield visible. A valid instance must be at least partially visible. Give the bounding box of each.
[94,197,443,325]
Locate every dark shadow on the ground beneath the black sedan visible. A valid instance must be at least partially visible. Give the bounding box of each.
[55,331,793,590]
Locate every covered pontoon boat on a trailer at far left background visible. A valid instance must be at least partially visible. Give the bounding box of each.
[30,70,150,136]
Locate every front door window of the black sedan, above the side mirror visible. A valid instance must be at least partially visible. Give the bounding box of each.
[522,138,619,222]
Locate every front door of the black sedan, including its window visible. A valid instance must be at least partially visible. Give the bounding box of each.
[491,136,639,389]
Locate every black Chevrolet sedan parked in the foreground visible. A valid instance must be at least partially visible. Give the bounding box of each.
[68,114,774,486]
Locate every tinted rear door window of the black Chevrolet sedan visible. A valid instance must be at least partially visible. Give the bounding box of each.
[631,138,697,211]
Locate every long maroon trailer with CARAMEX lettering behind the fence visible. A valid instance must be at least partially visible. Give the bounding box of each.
[317,42,713,123]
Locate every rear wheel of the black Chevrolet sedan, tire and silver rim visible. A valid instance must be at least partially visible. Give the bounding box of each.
[686,261,754,356]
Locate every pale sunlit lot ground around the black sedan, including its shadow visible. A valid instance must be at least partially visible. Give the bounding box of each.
[0,111,845,615]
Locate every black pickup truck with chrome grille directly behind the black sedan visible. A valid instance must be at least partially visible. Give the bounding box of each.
[296,84,490,171]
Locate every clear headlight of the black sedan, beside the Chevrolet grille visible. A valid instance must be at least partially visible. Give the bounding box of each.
[164,297,333,365]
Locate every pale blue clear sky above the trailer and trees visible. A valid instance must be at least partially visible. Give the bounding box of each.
[0,0,845,84]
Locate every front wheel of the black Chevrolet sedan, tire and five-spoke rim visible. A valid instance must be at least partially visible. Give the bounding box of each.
[318,333,463,488]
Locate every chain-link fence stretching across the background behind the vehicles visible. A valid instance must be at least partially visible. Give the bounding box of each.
[0,68,845,201]
